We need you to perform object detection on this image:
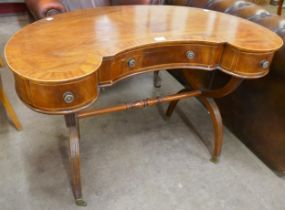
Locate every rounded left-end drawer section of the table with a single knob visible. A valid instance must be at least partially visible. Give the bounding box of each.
[14,72,99,114]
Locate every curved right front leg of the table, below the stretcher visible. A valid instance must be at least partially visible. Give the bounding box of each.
[198,97,223,163]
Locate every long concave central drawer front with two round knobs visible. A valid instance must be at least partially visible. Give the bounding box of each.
[110,44,222,81]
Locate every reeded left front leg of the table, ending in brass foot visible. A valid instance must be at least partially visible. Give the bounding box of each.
[64,114,87,206]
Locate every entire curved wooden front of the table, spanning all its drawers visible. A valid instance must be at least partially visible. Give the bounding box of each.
[14,42,274,114]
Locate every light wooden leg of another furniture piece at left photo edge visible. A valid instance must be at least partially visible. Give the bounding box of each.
[0,76,22,130]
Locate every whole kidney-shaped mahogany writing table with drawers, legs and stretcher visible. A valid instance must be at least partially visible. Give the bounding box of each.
[5,6,283,205]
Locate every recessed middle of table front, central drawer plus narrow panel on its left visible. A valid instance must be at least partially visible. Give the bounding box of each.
[98,42,223,86]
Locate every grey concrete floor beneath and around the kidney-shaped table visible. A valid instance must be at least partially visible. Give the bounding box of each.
[0,13,285,210]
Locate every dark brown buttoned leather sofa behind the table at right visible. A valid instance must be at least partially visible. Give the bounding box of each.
[167,0,285,176]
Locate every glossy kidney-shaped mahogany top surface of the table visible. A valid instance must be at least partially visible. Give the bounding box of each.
[5,6,283,83]
